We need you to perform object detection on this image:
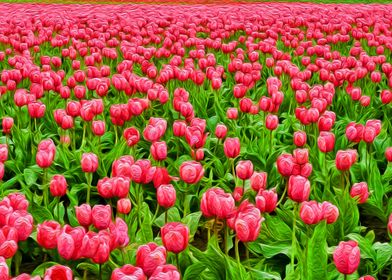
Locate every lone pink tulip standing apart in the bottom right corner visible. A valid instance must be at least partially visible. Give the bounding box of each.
[333,240,361,275]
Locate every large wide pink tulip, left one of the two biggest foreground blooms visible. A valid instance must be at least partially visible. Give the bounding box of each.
[200,188,234,219]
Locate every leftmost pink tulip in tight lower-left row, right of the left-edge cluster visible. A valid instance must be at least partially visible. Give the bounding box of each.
[37,221,61,249]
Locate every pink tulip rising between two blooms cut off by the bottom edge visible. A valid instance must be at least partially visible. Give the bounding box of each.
[136,242,166,277]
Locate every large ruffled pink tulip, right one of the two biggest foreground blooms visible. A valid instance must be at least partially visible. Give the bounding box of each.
[227,200,263,242]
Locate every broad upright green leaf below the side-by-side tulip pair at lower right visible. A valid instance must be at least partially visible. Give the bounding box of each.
[307,221,328,279]
